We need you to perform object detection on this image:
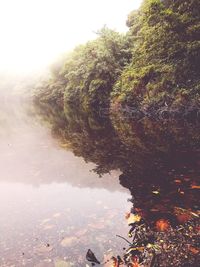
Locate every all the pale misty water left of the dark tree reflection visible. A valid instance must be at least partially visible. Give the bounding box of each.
[0,97,130,267]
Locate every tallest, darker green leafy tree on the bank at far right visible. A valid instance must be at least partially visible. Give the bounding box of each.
[112,0,200,109]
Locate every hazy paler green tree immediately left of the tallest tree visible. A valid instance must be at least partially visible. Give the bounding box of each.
[62,28,130,114]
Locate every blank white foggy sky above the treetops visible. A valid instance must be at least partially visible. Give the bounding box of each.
[0,0,142,73]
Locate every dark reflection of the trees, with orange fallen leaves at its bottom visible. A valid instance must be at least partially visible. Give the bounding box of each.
[33,99,200,266]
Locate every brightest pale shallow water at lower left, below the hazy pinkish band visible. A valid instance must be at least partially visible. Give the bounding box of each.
[0,183,130,267]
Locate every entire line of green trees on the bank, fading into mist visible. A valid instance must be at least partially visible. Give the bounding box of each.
[35,0,200,119]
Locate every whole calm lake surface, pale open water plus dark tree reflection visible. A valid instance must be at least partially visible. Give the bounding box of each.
[0,93,200,267]
